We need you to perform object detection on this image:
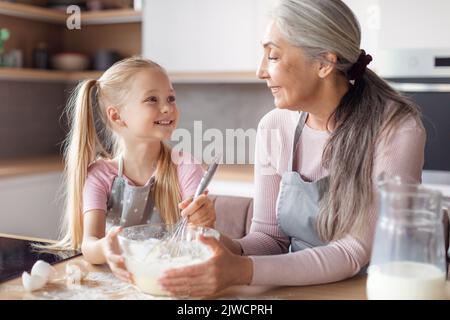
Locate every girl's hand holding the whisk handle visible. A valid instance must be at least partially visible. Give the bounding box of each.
[178,191,216,228]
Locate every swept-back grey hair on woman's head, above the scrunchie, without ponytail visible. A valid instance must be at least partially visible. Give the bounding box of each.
[271,0,361,78]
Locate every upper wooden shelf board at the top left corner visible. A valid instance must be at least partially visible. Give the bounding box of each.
[0,1,142,25]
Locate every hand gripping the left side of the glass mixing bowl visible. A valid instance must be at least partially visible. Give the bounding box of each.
[102,227,132,283]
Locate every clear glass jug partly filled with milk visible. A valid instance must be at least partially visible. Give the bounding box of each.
[367,179,447,300]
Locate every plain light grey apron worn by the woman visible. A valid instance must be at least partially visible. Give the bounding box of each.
[277,112,329,252]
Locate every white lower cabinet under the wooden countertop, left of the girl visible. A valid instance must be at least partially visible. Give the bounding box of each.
[0,172,62,239]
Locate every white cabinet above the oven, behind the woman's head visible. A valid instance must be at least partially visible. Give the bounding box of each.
[344,0,450,69]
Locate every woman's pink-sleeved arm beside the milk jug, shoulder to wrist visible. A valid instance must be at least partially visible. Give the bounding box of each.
[246,121,426,285]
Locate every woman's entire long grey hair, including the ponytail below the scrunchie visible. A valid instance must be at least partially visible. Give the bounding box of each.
[271,0,421,241]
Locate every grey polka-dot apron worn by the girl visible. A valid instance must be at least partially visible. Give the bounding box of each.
[106,156,162,231]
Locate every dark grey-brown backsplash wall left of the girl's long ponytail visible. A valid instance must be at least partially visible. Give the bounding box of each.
[0,81,66,158]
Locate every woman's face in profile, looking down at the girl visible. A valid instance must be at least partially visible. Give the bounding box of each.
[257,22,320,110]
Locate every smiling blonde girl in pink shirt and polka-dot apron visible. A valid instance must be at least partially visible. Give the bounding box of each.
[53,58,215,281]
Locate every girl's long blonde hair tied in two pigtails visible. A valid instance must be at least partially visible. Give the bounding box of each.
[51,57,181,249]
